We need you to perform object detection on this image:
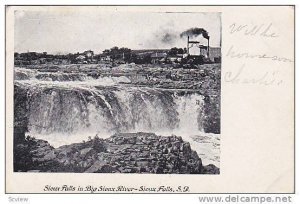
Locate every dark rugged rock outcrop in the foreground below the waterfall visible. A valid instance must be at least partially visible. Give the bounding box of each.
[15,132,219,174]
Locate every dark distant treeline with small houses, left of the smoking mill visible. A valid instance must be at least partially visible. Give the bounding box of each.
[14,46,220,65]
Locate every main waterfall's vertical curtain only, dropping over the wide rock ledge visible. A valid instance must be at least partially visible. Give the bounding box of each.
[22,84,202,142]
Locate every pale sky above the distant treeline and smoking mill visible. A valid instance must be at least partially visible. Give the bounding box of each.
[14,10,221,54]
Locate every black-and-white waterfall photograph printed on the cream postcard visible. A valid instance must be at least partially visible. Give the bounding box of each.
[13,9,222,174]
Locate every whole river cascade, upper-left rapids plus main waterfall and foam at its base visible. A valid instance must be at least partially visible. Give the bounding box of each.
[15,69,218,166]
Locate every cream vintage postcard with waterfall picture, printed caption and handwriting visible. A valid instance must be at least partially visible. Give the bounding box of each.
[6,6,294,193]
